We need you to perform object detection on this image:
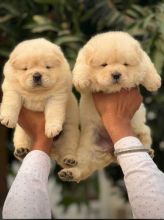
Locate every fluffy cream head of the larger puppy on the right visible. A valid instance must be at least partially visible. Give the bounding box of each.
[73,32,160,92]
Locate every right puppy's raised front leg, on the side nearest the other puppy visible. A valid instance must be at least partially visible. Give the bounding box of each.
[73,48,91,92]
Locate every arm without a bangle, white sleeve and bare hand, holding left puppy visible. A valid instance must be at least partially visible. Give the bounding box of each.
[3,109,52,219]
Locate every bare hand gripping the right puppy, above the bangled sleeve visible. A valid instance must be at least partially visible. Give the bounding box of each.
[93,88,142,143]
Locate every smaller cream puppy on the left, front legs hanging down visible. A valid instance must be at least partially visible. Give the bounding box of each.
[0,38,79,167]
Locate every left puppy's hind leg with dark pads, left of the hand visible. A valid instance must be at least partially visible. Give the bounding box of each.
[14,124,32,160]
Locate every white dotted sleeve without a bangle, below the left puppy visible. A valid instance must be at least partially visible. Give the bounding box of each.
[2,150,51,219]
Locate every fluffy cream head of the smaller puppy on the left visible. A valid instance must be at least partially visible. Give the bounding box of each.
[4,38,69,90]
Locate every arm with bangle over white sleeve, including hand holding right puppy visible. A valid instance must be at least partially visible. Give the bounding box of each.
[94,89,164,219]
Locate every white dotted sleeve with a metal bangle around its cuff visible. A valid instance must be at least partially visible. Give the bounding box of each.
[114,137,164,219]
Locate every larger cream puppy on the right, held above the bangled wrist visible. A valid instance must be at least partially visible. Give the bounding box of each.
[59,31,161,182]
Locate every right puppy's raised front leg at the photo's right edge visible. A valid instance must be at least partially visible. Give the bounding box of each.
[141,51,161,92]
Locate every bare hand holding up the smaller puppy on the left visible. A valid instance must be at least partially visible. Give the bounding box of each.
[18,107,53,155]
